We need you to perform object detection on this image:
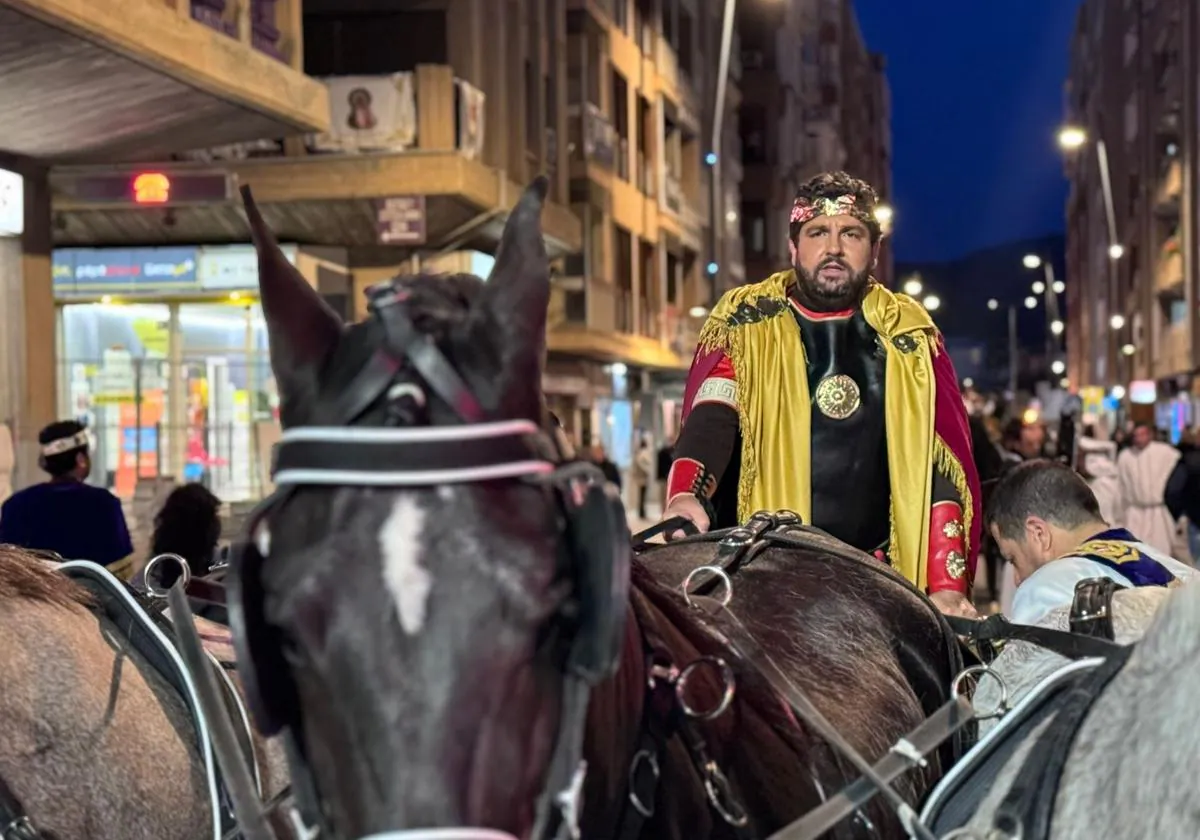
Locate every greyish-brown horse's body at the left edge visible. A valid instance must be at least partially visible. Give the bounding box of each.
[0,546,288,840]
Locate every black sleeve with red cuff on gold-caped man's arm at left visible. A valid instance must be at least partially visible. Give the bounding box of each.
[666,355,738,504]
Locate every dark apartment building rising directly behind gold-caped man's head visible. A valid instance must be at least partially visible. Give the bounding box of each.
[738,0,892,289]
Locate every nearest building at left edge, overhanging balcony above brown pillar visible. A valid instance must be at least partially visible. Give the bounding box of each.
[0,0,329,487]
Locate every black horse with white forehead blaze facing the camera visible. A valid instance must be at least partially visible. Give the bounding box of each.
[230,179,952,840]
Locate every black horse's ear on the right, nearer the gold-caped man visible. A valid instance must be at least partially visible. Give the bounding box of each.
[478,175,550,382]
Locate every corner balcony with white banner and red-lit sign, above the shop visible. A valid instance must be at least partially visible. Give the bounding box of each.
[50,65,582,255]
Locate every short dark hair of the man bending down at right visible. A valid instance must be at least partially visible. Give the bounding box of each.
[984,458,1103,540]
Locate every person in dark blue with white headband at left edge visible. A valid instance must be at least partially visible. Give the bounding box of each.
[0,420,133,580]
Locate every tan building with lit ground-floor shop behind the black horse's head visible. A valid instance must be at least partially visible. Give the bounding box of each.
[35,0,745,496]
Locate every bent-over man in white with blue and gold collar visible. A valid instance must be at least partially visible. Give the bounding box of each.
[985,461,1200,624]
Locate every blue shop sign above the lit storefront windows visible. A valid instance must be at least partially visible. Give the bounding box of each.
[53,247,197,295]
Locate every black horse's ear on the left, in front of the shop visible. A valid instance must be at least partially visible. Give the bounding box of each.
[241,186,342,425]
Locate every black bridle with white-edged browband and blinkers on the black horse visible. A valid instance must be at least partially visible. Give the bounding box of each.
[214,284,631,840]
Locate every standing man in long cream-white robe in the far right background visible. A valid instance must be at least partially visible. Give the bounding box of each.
[1117,425,1180,554]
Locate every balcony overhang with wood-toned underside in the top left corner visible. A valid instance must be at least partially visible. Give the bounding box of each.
[0,0,329,164]
